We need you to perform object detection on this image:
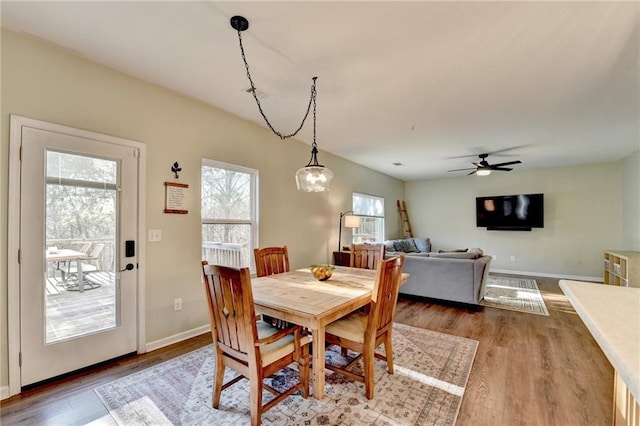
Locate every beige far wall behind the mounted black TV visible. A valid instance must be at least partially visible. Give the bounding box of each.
[405,162,624,277]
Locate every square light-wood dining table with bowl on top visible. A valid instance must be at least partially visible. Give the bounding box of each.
[251,266,409,399]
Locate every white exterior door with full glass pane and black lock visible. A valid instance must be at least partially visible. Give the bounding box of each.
[19,120,139,386]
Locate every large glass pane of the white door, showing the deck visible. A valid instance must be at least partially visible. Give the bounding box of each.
[44,149,118,344]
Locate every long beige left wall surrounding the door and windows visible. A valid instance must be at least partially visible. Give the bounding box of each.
[0,30,404,386]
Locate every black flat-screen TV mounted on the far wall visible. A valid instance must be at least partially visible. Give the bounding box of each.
[476,194,544,231]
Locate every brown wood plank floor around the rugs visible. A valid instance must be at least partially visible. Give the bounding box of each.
[0,277,613,426]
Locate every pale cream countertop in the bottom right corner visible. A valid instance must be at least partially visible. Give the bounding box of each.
[560,280,640,401]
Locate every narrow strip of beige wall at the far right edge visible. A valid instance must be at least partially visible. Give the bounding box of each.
[621,151,640,251]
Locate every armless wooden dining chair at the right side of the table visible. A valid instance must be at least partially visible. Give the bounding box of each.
[325,255,404,399]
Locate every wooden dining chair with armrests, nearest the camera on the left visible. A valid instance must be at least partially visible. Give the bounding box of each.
[202,260,309,426]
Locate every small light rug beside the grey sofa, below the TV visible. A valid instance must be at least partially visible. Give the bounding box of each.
[480,276,549,316]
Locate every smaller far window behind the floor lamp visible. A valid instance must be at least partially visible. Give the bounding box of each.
[353,192,384,244]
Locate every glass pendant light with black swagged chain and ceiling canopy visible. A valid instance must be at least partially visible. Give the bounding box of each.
[231,16,333,192]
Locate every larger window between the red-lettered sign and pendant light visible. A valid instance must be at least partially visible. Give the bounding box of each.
[200,159,258,272]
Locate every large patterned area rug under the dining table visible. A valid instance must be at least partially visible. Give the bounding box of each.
[95,324,478,426]
